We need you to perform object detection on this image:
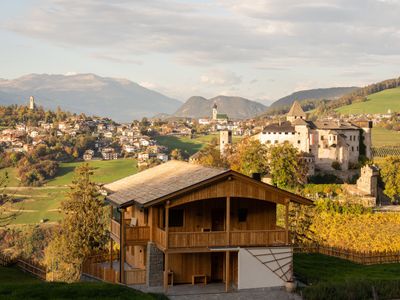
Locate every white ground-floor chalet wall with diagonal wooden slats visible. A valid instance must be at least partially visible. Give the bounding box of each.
[238,247,293,290]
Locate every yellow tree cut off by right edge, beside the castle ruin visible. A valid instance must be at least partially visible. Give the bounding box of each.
[381,156,400,201]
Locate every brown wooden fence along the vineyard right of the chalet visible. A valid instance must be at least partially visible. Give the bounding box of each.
[294,245,400,265]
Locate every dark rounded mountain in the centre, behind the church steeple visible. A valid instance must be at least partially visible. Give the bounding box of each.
[174,96,267,119]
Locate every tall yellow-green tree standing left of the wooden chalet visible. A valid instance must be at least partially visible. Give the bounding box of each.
[46,164,108,282]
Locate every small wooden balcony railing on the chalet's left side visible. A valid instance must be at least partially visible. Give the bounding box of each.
[111,220,150,245]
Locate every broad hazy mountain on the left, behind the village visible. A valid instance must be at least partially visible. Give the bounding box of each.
[0,74,182,122]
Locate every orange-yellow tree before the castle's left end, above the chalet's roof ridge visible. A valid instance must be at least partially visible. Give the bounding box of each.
[227,138,269,176]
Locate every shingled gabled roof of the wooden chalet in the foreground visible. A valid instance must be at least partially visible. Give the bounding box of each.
[104,161,312,207]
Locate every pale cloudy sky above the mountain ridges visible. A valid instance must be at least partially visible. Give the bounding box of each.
[0,0,400,103]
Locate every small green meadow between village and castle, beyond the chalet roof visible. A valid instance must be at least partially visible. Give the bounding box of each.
[155,134,241,155]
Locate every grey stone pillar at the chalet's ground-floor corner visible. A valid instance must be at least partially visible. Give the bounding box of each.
[146,242,164,287]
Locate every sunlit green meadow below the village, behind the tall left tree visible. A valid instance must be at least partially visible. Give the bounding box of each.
[0,159,138,224]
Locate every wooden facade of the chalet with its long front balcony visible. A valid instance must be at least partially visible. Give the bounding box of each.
[106,166,309,291]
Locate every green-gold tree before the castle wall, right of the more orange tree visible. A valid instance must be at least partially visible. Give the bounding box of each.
[269,143,308,188]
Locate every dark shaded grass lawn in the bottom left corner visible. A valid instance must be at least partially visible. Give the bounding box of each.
[0,267,167,300]
